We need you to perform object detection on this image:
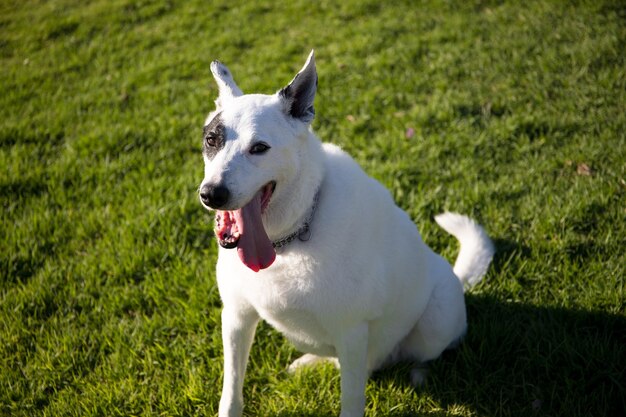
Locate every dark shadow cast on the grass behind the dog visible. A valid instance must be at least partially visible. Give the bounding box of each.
[373,295,626,416]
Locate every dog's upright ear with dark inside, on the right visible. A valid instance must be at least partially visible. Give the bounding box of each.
[278,51,317,123]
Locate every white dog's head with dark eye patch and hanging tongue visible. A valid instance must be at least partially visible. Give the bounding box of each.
[200,52,317,271]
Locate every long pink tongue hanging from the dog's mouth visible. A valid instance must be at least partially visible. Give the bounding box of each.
[233,190,276,272]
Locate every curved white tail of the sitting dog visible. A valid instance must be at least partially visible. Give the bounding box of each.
[435,212,495,289]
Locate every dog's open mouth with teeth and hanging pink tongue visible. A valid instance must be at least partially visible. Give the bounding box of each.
[215,181,276,272]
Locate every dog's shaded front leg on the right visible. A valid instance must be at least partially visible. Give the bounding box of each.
[336,323,369,417]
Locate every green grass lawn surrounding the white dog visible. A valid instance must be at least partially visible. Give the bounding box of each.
[0,0,626,417]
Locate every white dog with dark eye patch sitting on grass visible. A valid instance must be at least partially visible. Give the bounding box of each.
[200,52,494,417]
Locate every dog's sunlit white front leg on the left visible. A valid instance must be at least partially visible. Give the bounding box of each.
[219,306,259,417]
